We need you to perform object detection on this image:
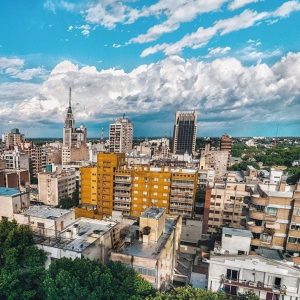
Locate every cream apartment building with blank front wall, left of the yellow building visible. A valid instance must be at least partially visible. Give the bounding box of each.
[38,170,76,206]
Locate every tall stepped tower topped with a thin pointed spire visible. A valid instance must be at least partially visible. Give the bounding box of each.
[62,88,88,164]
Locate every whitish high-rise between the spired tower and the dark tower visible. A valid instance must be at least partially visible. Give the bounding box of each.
[109,115,133,153]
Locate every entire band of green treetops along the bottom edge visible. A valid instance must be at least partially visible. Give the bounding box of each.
[0,220,258,300]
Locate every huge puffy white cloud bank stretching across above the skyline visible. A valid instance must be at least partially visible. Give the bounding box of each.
[0,53,300,134]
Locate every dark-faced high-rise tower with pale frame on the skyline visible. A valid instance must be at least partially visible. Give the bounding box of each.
[173,111,197,154]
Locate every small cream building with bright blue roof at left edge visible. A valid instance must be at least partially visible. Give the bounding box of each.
[0,187,30,220]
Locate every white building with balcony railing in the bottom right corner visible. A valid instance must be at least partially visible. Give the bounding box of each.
[208,253,300,300]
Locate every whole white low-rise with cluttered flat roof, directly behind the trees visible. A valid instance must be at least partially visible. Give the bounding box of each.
[36,218,120,266]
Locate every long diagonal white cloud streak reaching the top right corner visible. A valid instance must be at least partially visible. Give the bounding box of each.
[141,1,300,57]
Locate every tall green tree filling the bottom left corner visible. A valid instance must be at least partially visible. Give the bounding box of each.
[0,220,45,299]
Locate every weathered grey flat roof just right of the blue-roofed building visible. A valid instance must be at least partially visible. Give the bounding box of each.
[22,205,71,220]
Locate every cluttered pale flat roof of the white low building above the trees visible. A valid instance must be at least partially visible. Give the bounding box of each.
[37,218,118,253]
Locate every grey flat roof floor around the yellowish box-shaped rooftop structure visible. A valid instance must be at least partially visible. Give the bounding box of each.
[116,219,176,259]
